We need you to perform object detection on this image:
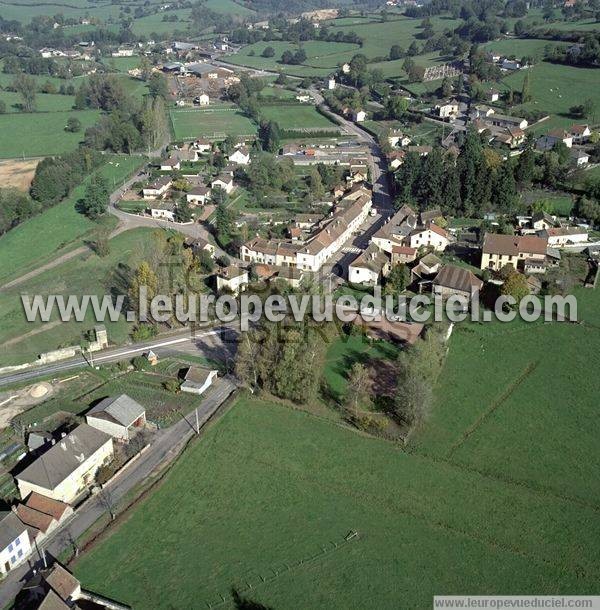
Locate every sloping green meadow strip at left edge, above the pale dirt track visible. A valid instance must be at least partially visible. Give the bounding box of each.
[0,156,144,284]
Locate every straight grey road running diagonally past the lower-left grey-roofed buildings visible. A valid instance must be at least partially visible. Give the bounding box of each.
[0,378,236,608]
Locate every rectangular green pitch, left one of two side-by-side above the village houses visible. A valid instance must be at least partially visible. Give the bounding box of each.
[171,105,256,140]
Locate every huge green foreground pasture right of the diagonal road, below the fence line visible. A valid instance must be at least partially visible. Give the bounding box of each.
[71,388,600,610]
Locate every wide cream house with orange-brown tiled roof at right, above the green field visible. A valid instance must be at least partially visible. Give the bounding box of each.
[481,233,548,271]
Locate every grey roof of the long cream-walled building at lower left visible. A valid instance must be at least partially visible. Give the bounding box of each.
[15,424,112,489]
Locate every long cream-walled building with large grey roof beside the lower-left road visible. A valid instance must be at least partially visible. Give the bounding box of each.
[15,424,114,504]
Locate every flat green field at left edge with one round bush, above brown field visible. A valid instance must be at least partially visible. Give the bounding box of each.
[0,110,100,159]
